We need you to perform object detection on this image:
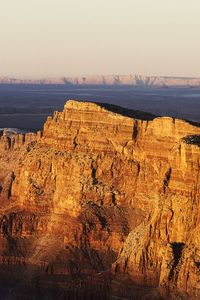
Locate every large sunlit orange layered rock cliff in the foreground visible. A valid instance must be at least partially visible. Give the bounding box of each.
[0,100,200,299]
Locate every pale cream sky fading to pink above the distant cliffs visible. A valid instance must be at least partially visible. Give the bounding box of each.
[0,0,200,78]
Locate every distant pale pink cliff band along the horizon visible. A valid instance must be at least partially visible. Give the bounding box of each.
[0,75,200,88]
